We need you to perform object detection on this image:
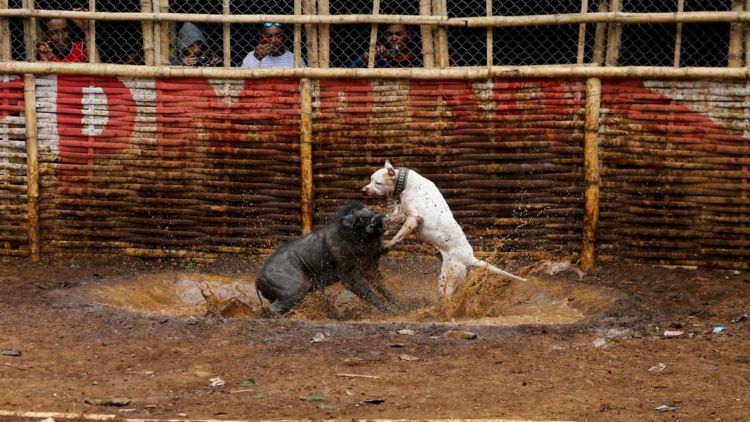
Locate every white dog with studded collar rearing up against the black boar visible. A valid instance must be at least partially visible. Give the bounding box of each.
[362,161,526,298]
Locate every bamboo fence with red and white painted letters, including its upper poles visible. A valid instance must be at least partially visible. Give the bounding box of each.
[0,4,750,269]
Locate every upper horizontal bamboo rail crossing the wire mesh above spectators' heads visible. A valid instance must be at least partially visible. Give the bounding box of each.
[0,8,750,28]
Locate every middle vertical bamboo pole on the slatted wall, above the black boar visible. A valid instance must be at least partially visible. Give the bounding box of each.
[300,78,313,235]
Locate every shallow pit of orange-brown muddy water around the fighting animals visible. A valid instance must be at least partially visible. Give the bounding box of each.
[75,261,615,326]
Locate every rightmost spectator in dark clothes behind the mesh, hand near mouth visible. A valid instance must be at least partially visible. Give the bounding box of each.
[348,24,422,67]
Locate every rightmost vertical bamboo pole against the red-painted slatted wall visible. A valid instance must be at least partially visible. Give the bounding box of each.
[581,78,602,271]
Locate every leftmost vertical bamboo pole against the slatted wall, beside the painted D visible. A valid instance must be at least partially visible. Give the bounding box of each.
[23,73,39,261]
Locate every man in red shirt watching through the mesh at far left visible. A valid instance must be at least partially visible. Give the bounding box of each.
[36,14,97,63]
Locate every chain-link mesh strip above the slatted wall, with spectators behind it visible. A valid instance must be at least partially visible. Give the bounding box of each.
[2,0,744,68]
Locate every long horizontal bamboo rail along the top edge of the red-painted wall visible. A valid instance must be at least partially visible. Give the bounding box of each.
[0,62,750,80]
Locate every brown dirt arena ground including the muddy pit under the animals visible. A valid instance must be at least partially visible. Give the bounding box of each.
[0,252,750,421]
